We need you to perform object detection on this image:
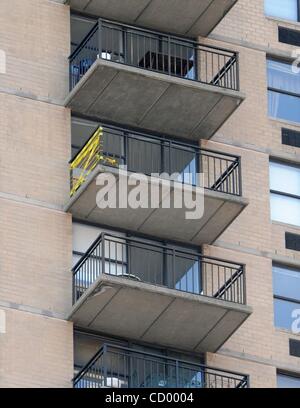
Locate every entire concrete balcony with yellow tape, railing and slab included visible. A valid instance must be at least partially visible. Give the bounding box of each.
[65,126,248,245]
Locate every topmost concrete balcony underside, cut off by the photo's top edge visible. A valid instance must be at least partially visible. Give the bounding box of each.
[66,0,237,37]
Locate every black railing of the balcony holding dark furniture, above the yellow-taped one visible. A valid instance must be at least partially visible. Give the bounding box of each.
[69,19,239,91]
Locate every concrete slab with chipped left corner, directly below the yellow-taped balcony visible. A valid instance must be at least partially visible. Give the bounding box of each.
[68,275,252,352]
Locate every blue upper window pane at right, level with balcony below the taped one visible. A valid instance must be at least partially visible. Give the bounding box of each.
[273,266,300,302]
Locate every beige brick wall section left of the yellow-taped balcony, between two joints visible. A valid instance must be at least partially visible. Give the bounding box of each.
[0,93,71,207]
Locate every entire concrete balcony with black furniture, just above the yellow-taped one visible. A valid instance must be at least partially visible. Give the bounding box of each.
[65,20,244,140]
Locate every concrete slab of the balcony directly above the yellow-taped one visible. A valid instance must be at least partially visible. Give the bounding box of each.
[65,59,244,140]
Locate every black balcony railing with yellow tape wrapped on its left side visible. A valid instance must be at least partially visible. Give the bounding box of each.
[70,126,242,196]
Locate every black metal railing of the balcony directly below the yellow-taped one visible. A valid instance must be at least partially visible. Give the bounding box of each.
[73,233,246,304]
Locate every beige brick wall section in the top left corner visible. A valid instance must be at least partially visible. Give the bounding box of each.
[0,0,70,101]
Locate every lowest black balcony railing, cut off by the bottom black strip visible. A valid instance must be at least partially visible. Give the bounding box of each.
[73,344,248,388]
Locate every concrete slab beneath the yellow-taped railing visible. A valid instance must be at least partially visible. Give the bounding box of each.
[65,165,248,245]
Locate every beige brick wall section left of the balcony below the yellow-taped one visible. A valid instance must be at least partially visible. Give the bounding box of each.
[0,198,72,317]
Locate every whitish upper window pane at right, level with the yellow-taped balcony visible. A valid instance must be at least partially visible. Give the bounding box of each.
[270,162,300,197]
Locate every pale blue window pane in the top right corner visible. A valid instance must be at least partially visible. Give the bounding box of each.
[265,0,300,21]
